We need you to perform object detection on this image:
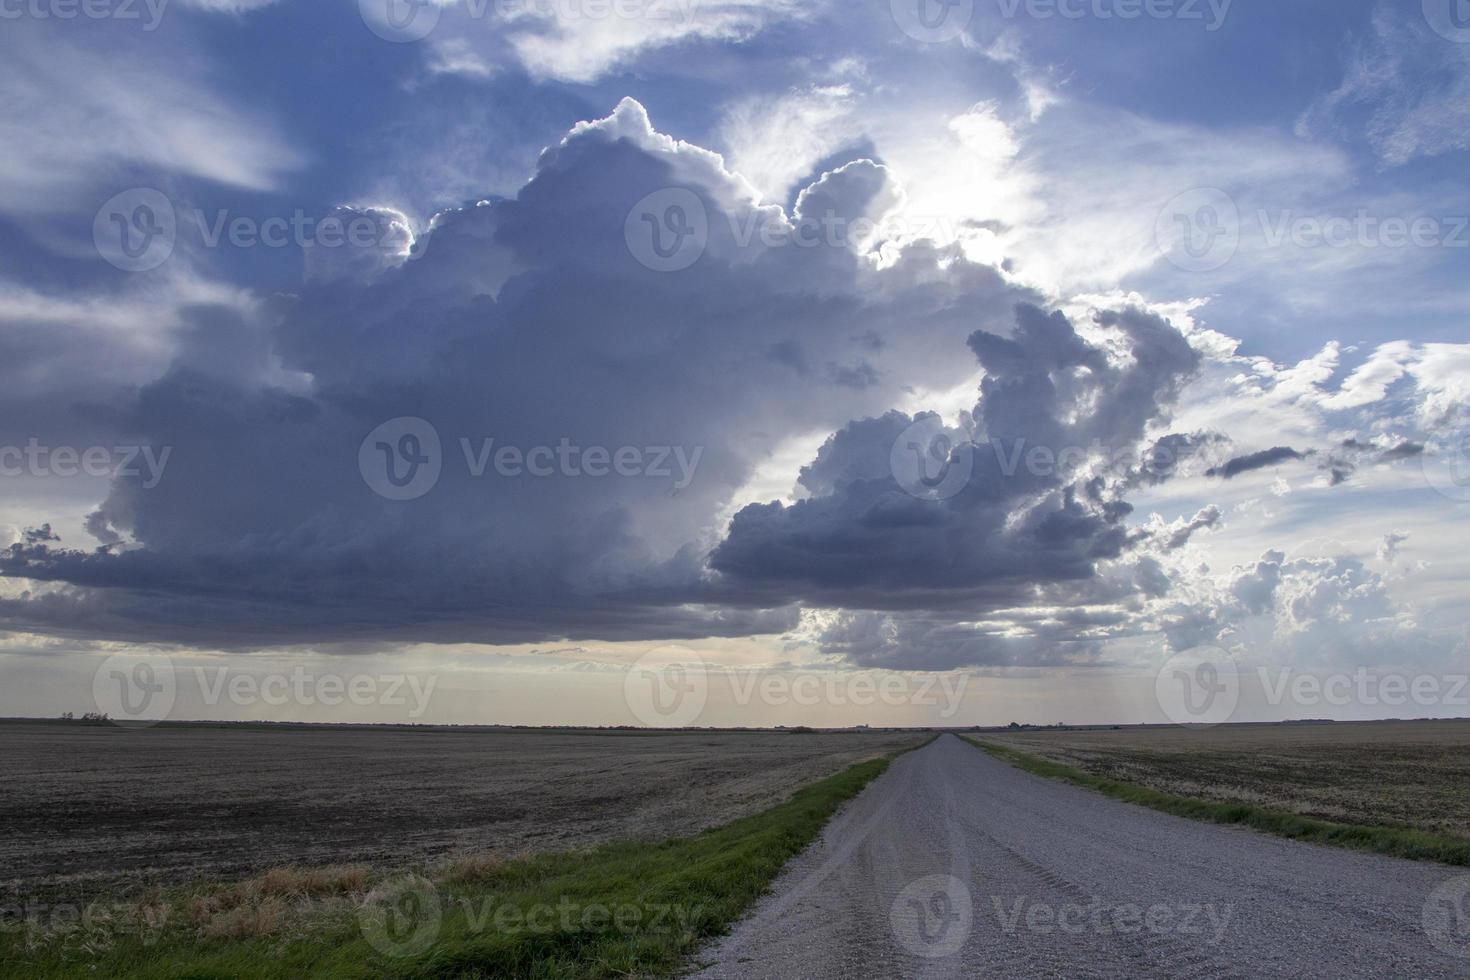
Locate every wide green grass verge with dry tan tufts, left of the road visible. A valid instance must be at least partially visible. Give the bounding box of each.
[0,738,933,980]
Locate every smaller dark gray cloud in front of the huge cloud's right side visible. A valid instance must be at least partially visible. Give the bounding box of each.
[710,304,1198,610]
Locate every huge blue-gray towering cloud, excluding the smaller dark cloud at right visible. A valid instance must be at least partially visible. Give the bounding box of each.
[0,103,1058,645]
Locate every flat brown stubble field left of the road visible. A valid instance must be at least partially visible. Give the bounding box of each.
[0,723,916,895]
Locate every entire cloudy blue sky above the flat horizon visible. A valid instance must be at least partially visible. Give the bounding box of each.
[0,0,1470,726]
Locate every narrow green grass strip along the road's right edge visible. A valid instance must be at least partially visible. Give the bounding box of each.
[964,738,1470,865]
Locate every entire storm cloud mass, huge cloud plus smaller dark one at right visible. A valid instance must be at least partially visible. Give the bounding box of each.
[0,100,1464,667]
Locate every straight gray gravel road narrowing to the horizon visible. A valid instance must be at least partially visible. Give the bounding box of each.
[697,735,1470,980]
